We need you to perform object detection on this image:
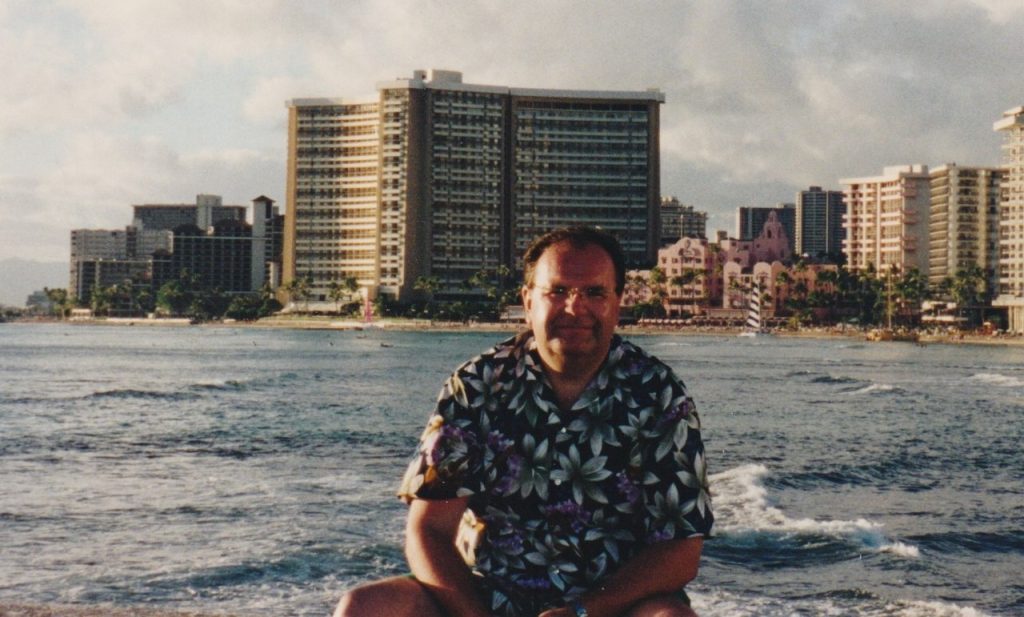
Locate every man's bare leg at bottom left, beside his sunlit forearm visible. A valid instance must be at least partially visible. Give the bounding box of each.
[334,576,444,617]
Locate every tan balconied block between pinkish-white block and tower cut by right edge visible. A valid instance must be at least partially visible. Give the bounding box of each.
[928,163,1002,292]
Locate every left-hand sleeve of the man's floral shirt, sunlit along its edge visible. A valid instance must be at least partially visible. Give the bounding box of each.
[398,372,484,502]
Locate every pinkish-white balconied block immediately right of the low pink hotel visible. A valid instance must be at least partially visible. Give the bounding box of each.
[840,165,930,275]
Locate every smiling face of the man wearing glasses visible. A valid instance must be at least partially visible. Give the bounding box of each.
[522,243,621,371]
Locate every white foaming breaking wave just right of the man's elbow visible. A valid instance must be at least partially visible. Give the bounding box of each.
[711,464,920,558]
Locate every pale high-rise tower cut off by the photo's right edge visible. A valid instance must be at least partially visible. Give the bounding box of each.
[992,106,1024,334]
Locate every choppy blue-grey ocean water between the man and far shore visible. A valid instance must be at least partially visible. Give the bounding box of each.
[0,324,1024,617]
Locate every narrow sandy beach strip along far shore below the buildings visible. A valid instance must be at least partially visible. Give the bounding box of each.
[8,317,1024,347]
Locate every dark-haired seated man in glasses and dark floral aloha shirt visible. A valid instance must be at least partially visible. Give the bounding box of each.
[335,227,714,617]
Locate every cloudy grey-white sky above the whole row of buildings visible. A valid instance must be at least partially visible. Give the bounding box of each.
[0,0,1024,262]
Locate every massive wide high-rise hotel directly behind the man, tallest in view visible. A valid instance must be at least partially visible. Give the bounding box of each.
[284,71,665,300]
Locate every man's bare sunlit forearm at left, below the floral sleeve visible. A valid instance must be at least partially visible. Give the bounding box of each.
[406,497,488,617]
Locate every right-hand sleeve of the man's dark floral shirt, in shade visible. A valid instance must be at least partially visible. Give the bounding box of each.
[641,364,715,543]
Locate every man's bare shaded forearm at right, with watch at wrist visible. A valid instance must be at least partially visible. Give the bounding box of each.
[541,536,703,617]
